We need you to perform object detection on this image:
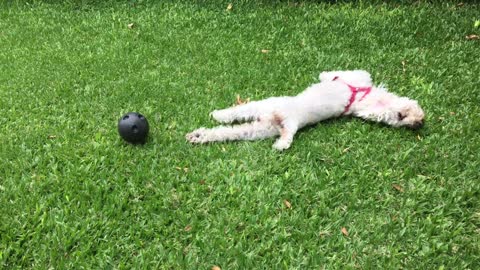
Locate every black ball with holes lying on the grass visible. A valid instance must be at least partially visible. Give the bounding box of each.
[118,112,148,144]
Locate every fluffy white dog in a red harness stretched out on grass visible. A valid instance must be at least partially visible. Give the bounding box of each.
[186,70,424,150]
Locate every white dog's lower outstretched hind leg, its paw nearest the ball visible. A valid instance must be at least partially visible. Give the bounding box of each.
[185,119,279,143]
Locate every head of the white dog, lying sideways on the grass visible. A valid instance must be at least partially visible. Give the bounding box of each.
[388,97,425,129]
